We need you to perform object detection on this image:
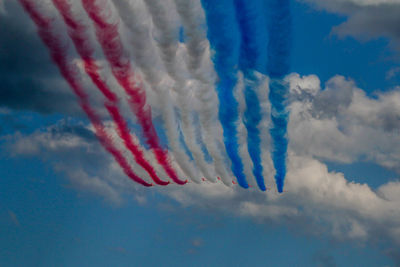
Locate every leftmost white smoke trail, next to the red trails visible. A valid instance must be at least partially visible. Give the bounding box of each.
[113,0,200,182]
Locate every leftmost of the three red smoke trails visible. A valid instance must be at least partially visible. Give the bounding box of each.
[19,0,153,187]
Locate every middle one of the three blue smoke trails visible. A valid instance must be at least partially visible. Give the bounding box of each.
[235,0,268,191]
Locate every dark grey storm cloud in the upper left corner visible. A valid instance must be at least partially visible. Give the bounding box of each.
[0,1,80,115]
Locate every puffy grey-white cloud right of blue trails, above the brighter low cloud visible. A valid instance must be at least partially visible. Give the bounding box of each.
[288,74,400,172]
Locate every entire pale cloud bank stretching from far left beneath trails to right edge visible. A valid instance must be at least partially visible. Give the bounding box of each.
[8,74,400,251]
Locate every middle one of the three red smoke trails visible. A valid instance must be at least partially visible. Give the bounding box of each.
[53,0,169,185]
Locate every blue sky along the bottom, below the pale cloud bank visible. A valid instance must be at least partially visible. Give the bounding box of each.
[0,154,392,266]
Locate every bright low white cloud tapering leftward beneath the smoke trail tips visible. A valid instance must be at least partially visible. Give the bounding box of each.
[162,154,400,245]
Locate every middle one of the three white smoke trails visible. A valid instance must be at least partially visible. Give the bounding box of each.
[140,0,216,182]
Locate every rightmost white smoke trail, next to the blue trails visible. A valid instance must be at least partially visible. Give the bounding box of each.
[175,0,232,186]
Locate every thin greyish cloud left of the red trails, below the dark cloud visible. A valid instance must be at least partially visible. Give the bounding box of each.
[0,120,146,204]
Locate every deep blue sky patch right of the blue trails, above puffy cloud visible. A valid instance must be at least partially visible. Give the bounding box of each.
[292,2,399,92]
